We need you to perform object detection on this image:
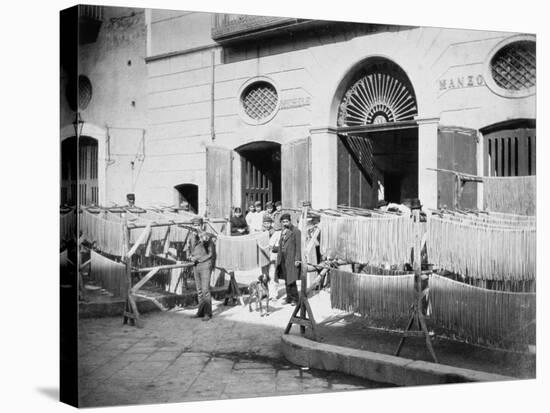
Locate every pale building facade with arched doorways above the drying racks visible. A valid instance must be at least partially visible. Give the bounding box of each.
[62,9,536,217]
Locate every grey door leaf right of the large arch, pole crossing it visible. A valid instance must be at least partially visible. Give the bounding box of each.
[440,126,478,209]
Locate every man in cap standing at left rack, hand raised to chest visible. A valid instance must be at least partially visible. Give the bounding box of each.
[187,217,215,321]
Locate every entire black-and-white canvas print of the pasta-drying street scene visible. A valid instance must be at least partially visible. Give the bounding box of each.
[50,2,542,411]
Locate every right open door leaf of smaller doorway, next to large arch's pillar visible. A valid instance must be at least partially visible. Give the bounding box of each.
[281,137,311,208]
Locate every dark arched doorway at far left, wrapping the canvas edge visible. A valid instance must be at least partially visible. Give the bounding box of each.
[60,136,99,205]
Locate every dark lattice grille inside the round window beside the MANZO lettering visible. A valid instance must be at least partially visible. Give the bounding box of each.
[491,41,537,90]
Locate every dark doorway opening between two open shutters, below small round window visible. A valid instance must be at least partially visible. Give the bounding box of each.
[236,141,281,209]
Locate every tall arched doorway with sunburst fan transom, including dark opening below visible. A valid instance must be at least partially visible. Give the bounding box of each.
[337,57,418,208]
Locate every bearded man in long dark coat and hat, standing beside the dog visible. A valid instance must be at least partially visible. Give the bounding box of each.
[275,213,302,305]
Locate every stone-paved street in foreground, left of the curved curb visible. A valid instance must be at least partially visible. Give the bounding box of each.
[79,294,387,407]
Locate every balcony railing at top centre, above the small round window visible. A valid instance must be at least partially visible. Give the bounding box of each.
[212,14,300,42]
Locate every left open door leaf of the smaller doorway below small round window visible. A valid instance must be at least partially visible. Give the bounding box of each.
[206,146,233,218]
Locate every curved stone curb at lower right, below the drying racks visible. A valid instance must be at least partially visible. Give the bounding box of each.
[281,334,519,386]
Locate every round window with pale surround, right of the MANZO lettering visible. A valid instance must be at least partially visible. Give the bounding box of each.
[487,36,537,97]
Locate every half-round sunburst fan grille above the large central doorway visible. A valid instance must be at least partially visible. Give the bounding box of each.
[338,71,417,126]
